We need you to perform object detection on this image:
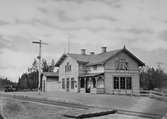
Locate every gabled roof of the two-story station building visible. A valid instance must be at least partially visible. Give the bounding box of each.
[56,47,145,66]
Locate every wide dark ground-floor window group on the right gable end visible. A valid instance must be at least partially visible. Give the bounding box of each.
[113,77,132,89]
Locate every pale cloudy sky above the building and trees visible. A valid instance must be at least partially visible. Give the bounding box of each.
[0,0,167,81]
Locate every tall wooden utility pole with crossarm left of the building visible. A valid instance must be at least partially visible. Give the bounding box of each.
[32,40,48,95]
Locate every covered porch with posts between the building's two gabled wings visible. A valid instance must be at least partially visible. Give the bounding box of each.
[79,73,104,94]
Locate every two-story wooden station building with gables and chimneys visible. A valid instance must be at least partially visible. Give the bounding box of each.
[56,47,144,94]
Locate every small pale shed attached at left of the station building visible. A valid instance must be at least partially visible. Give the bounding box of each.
[42,72,60,92]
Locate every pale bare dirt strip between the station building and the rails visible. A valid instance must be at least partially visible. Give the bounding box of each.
[5,91,167,115]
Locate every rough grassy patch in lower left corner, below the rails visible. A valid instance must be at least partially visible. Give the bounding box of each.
[0,98,72,119]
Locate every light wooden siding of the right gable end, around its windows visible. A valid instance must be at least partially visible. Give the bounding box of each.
[104,52,140,93]
